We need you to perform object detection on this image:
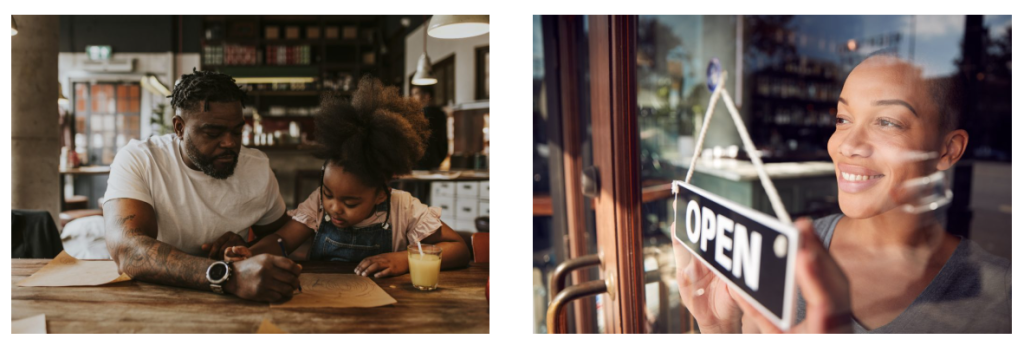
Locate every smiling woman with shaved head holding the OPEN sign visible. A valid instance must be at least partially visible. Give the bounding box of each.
[676,55,1011,333]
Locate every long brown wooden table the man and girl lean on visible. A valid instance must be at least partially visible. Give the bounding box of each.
[11,259,490,334]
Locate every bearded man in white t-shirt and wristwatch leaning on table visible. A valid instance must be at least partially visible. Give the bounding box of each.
[103,70,301,302]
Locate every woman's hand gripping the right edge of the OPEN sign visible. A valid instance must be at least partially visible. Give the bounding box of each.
[734,218,853,334]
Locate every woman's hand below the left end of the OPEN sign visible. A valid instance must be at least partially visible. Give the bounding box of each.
[672,233,742,334]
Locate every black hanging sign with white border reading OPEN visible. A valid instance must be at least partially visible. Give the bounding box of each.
[672,181,798,331]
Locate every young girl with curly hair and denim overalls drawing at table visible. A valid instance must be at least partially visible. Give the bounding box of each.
[224,78,469,277]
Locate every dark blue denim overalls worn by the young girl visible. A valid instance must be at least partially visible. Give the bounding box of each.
[309,202,392,262]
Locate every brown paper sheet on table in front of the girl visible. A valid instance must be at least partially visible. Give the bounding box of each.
[270,274,398,308]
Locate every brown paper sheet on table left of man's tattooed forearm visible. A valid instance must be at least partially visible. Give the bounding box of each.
[17,252,131,287]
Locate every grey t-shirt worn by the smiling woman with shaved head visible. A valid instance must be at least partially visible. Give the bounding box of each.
[797,214,1011,334]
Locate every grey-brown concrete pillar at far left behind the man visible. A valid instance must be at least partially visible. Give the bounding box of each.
[10,15,60,225]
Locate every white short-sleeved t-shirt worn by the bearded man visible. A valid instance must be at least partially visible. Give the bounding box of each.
[103,134,285,255]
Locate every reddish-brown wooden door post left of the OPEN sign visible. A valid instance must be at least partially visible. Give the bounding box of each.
[589,15,646,334]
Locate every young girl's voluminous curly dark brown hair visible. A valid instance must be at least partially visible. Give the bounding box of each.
[315,77,430,187]
